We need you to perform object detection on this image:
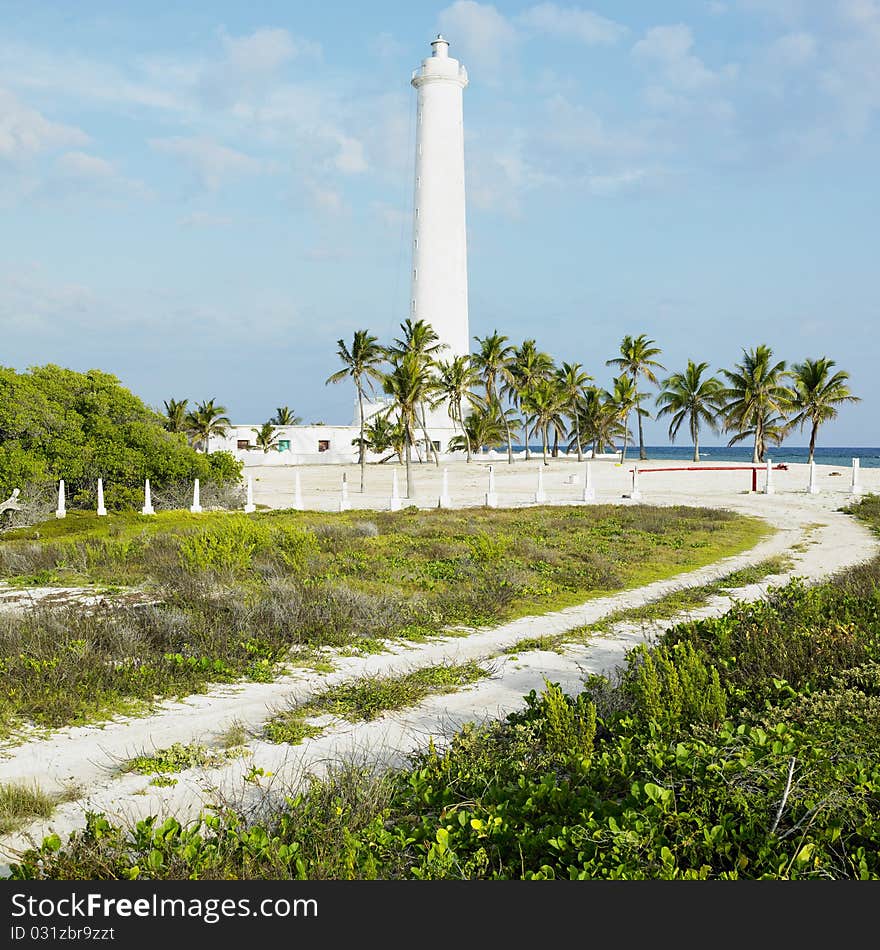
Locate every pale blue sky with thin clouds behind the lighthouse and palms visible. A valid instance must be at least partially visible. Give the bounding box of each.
[0,0,880,445]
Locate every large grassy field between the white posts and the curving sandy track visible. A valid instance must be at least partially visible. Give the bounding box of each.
[0,505,769,736]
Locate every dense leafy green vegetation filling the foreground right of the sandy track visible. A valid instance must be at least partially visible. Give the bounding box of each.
[10,502,880,880]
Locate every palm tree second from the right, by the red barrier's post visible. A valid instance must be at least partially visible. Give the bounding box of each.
[721,344,792,463]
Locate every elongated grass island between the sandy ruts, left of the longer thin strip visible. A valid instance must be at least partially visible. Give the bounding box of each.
[264,662,491,744]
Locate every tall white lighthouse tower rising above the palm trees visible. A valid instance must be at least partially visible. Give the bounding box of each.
[410,36,470,360]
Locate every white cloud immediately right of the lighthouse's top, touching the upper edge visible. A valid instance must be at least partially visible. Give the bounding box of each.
[437,0,519,78]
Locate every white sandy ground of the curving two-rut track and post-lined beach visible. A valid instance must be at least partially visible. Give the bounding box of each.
[0,458,880,861]
